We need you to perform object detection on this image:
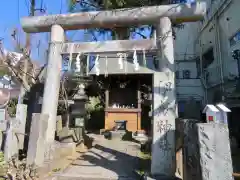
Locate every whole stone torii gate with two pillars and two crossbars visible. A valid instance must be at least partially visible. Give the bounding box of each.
[21,2,206,176]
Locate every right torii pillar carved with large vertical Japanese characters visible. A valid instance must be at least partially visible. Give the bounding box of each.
[151,17,177,176]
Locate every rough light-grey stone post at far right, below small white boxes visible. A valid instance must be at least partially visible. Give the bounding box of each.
[197,123,233,180]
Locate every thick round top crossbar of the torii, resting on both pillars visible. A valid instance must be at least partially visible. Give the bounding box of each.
[21,3,206,33]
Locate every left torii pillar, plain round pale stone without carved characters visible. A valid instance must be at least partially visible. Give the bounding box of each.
[42,25,65,144]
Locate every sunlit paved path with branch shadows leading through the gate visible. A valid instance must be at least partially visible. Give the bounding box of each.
[49,135,140,180]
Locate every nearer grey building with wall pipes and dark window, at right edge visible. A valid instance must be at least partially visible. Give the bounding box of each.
[192,0,240,107]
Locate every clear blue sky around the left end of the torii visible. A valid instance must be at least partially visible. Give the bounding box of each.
[0,0,88,63]
